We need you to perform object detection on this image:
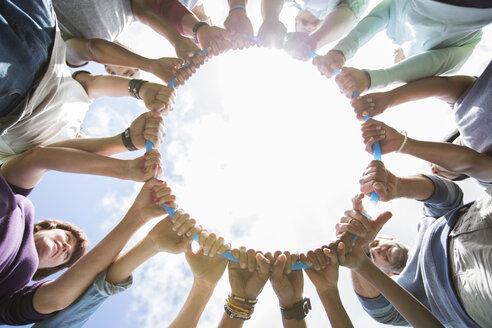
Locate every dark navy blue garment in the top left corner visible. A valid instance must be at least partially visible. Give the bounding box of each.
[0,0,56,116]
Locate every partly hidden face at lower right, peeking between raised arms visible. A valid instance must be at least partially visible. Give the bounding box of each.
[369,238,408,273]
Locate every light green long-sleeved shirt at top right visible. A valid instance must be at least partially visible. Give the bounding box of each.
[333,0,492,89]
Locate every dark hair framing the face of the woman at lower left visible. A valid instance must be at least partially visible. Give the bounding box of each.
[32,219,89,280]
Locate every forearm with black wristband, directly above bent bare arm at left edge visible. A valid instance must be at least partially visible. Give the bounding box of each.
[48,134,128,156]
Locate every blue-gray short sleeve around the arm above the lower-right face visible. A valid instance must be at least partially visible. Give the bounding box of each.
[423,175,463,218]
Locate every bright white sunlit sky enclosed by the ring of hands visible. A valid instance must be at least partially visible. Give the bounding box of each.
[165,48,370,251]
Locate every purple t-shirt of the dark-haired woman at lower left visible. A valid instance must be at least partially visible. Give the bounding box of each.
[0,175,51,325]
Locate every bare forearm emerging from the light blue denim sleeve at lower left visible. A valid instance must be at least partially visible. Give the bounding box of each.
[106,237,158,285]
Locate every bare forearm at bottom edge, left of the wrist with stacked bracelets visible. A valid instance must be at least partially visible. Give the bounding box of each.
[169,281,214,328]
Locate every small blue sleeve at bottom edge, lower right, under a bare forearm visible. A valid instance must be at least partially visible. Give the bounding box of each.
[357,295,410,326]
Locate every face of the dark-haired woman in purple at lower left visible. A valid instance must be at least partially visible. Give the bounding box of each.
[34,229,77,269]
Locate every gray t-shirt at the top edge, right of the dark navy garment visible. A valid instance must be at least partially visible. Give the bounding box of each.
[52,0,133,41]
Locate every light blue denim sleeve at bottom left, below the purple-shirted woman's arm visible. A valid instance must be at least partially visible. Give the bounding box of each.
[32,271,133,328]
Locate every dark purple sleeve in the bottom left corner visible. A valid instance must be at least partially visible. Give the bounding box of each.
[0,281,53,325]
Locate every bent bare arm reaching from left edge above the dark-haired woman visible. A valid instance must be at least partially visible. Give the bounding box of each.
[1,147,128,189]
